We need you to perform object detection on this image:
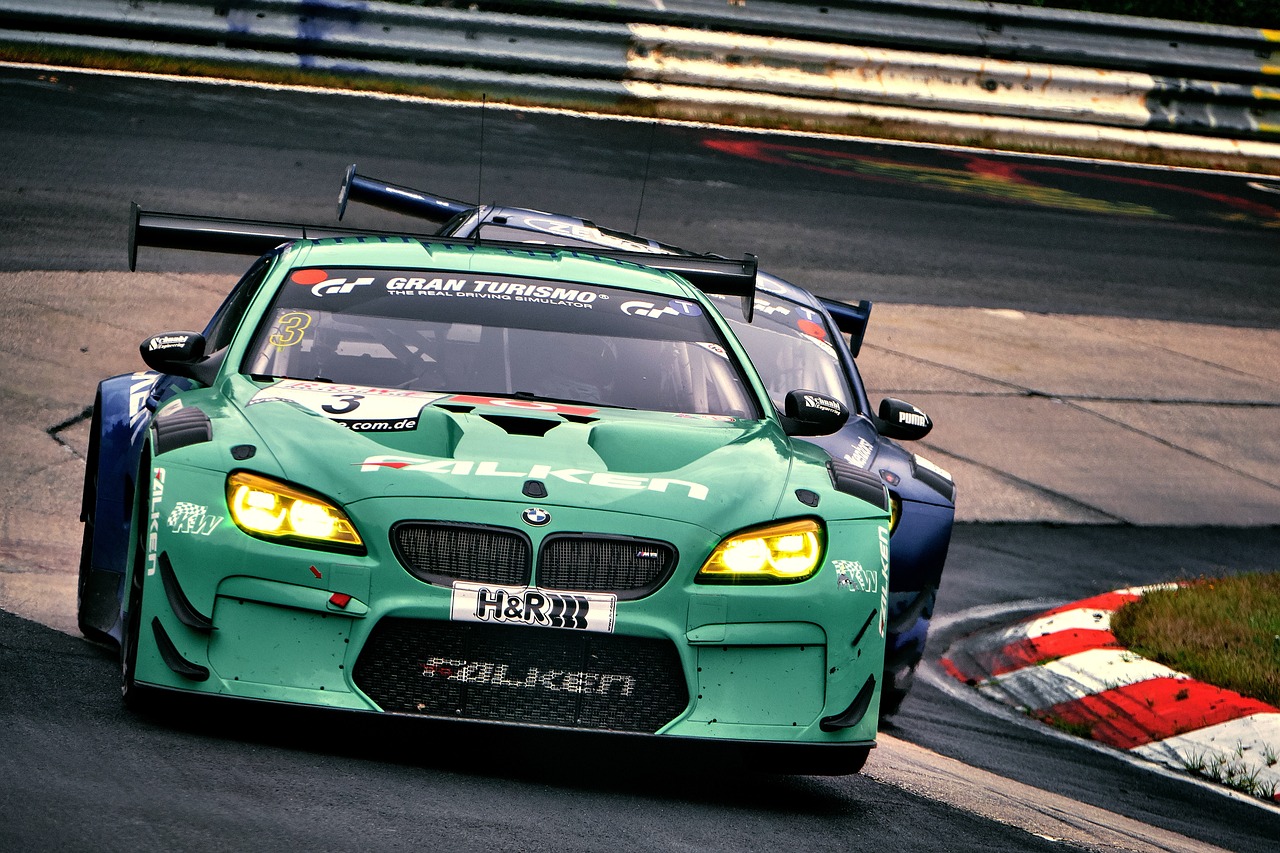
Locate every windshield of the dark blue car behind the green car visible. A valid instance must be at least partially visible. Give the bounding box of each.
[713,295,858,411]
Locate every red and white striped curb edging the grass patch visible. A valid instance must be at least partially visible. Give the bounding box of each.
[942,584,1280,803]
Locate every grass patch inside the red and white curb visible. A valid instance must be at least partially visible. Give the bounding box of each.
[1111,573,1280,707]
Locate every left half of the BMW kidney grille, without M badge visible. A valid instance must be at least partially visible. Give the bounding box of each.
[392,521,531,587]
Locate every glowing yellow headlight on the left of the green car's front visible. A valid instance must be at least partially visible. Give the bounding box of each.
[227,471,365,553]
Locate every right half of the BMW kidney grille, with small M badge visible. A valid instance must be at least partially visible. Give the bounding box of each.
[538,535,676,598]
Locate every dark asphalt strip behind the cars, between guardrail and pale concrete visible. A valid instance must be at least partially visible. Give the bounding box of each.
[10,69,1280,328]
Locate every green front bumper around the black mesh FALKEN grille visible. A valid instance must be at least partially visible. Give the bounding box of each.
[136,470,887,747]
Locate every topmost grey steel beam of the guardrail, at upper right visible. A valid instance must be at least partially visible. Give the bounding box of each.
[481,0,1280,85]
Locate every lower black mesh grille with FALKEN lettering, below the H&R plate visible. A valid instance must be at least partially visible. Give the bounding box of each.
[353,617,689,733]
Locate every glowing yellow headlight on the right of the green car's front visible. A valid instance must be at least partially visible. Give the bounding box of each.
[698,519,823,583]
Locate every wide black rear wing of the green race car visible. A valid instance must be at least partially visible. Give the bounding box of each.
[129,204,758,302]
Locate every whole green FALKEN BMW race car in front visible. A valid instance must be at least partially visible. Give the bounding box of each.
[79,211,888,772]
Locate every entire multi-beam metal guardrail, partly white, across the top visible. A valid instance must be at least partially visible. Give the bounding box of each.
[0,0,1280,140]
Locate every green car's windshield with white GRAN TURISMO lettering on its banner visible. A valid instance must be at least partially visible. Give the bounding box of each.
[242,262,759,419]
